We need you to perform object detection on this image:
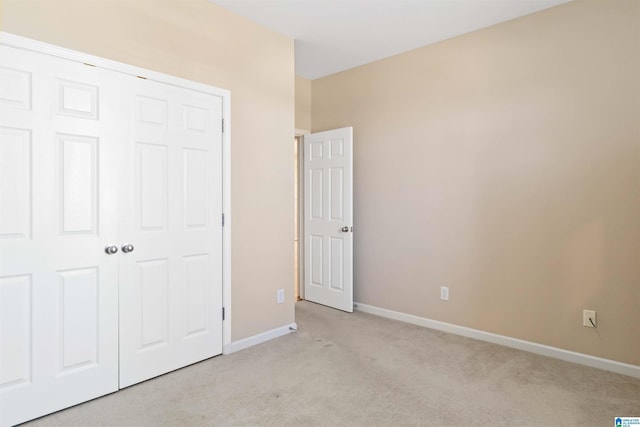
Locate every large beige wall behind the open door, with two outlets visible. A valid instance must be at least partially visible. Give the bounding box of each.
[312,0,640,365]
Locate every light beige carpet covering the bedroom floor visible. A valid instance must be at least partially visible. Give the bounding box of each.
[23,302,640,427]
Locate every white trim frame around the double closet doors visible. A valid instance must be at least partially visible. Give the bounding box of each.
[0,31,232,354]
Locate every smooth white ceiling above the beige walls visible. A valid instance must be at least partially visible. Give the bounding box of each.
[209,0,570,79]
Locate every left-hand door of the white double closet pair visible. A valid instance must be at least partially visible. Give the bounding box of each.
[0,46,120,426]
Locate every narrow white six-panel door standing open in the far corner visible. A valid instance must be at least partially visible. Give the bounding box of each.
[304,127,353,312]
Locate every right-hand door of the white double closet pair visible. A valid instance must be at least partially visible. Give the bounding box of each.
[120,78,222,387]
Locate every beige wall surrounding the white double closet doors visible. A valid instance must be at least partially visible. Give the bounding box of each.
[2,0,294,340]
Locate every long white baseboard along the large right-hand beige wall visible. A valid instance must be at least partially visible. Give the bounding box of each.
[354,303,640,378]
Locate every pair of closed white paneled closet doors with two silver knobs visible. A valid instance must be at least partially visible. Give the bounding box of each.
[0,46,222,426]
